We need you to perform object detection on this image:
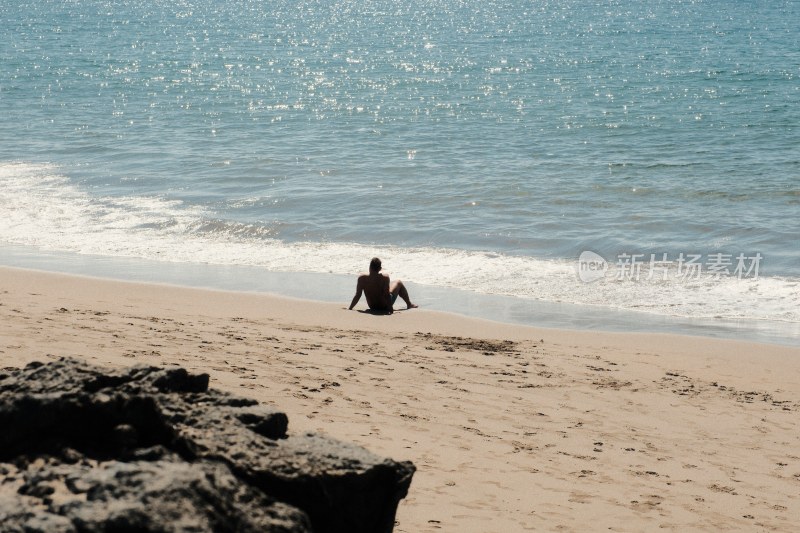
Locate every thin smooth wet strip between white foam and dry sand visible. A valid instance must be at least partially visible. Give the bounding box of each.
[0,241,800,346]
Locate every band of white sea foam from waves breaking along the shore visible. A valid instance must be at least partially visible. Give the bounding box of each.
[0,163,800,323]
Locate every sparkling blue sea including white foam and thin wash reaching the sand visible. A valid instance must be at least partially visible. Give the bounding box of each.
[0,0,800,344]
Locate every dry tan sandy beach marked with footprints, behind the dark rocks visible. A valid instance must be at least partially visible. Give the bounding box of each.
[0,268,800,533]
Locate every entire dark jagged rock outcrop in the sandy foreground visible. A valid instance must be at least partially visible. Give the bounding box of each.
[0,359,414,533]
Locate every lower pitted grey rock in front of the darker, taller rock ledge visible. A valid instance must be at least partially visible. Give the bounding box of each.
[0,456,311,533]
